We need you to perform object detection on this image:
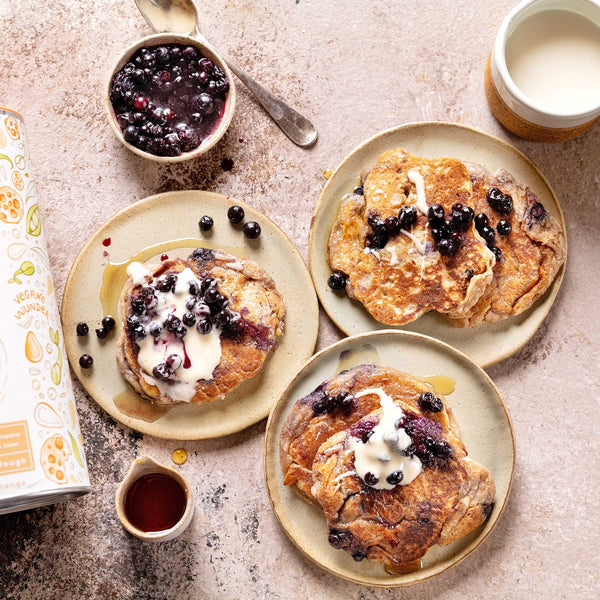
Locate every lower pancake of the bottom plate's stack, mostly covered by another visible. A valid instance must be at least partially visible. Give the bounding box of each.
[280,365,460,501]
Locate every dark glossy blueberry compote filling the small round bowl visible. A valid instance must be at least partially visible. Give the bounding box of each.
[110,44,229,156]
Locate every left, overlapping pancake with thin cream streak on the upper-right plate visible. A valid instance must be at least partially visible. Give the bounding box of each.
[328,149,495,325]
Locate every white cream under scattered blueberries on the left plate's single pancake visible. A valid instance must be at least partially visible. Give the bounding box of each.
[134,263,221,402]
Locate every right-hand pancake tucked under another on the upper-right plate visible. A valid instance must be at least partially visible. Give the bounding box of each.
[449,163,566,327]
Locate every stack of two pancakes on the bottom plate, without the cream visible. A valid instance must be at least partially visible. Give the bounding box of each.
[280,365,495,571]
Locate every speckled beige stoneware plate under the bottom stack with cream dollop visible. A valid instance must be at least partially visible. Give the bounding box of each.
[264,331,515,587]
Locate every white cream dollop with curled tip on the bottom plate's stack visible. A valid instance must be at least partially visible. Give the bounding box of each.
[350,388,423,490]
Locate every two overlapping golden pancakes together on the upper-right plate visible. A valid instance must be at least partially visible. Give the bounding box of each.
[328,149,566,327]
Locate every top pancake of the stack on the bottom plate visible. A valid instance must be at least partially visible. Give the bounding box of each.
[313,403,495,572]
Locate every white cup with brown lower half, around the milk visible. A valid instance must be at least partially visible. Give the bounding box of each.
[485,0,600,142]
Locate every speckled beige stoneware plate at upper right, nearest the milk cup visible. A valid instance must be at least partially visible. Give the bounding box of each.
[308,122,567,367]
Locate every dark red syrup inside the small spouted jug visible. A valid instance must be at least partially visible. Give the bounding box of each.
[125,473,187,532]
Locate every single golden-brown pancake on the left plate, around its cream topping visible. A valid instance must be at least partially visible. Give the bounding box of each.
[117,248,285,405]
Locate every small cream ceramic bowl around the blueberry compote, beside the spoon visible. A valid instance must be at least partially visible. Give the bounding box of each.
[104,33,236,163]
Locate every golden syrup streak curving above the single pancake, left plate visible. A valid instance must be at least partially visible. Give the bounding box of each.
[100,238,247,315]
